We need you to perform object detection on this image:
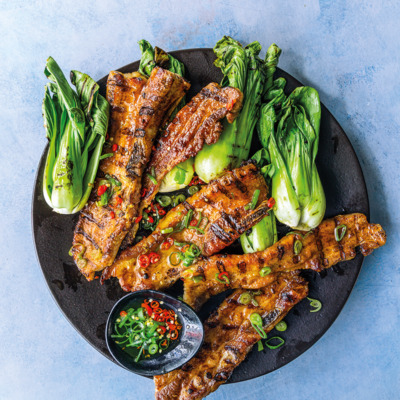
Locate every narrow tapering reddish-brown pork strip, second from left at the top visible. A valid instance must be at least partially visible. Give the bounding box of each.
[122,83,243,248]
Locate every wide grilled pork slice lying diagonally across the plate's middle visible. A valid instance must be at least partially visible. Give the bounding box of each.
[103,163,268,291]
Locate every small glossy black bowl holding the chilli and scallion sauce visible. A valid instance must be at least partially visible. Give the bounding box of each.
[106,290,204,376]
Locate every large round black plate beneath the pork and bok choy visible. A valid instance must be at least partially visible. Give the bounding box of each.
[32,49,369,382]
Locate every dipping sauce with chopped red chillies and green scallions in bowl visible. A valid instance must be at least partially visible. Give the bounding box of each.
[111,299,182,362]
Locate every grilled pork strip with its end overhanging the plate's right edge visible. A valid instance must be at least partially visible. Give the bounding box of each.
[183,214,386,309]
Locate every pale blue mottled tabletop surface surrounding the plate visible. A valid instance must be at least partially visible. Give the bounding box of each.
[0,0,400,400]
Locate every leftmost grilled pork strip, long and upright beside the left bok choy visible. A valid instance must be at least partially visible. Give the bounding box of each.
[72,68,190,280]
